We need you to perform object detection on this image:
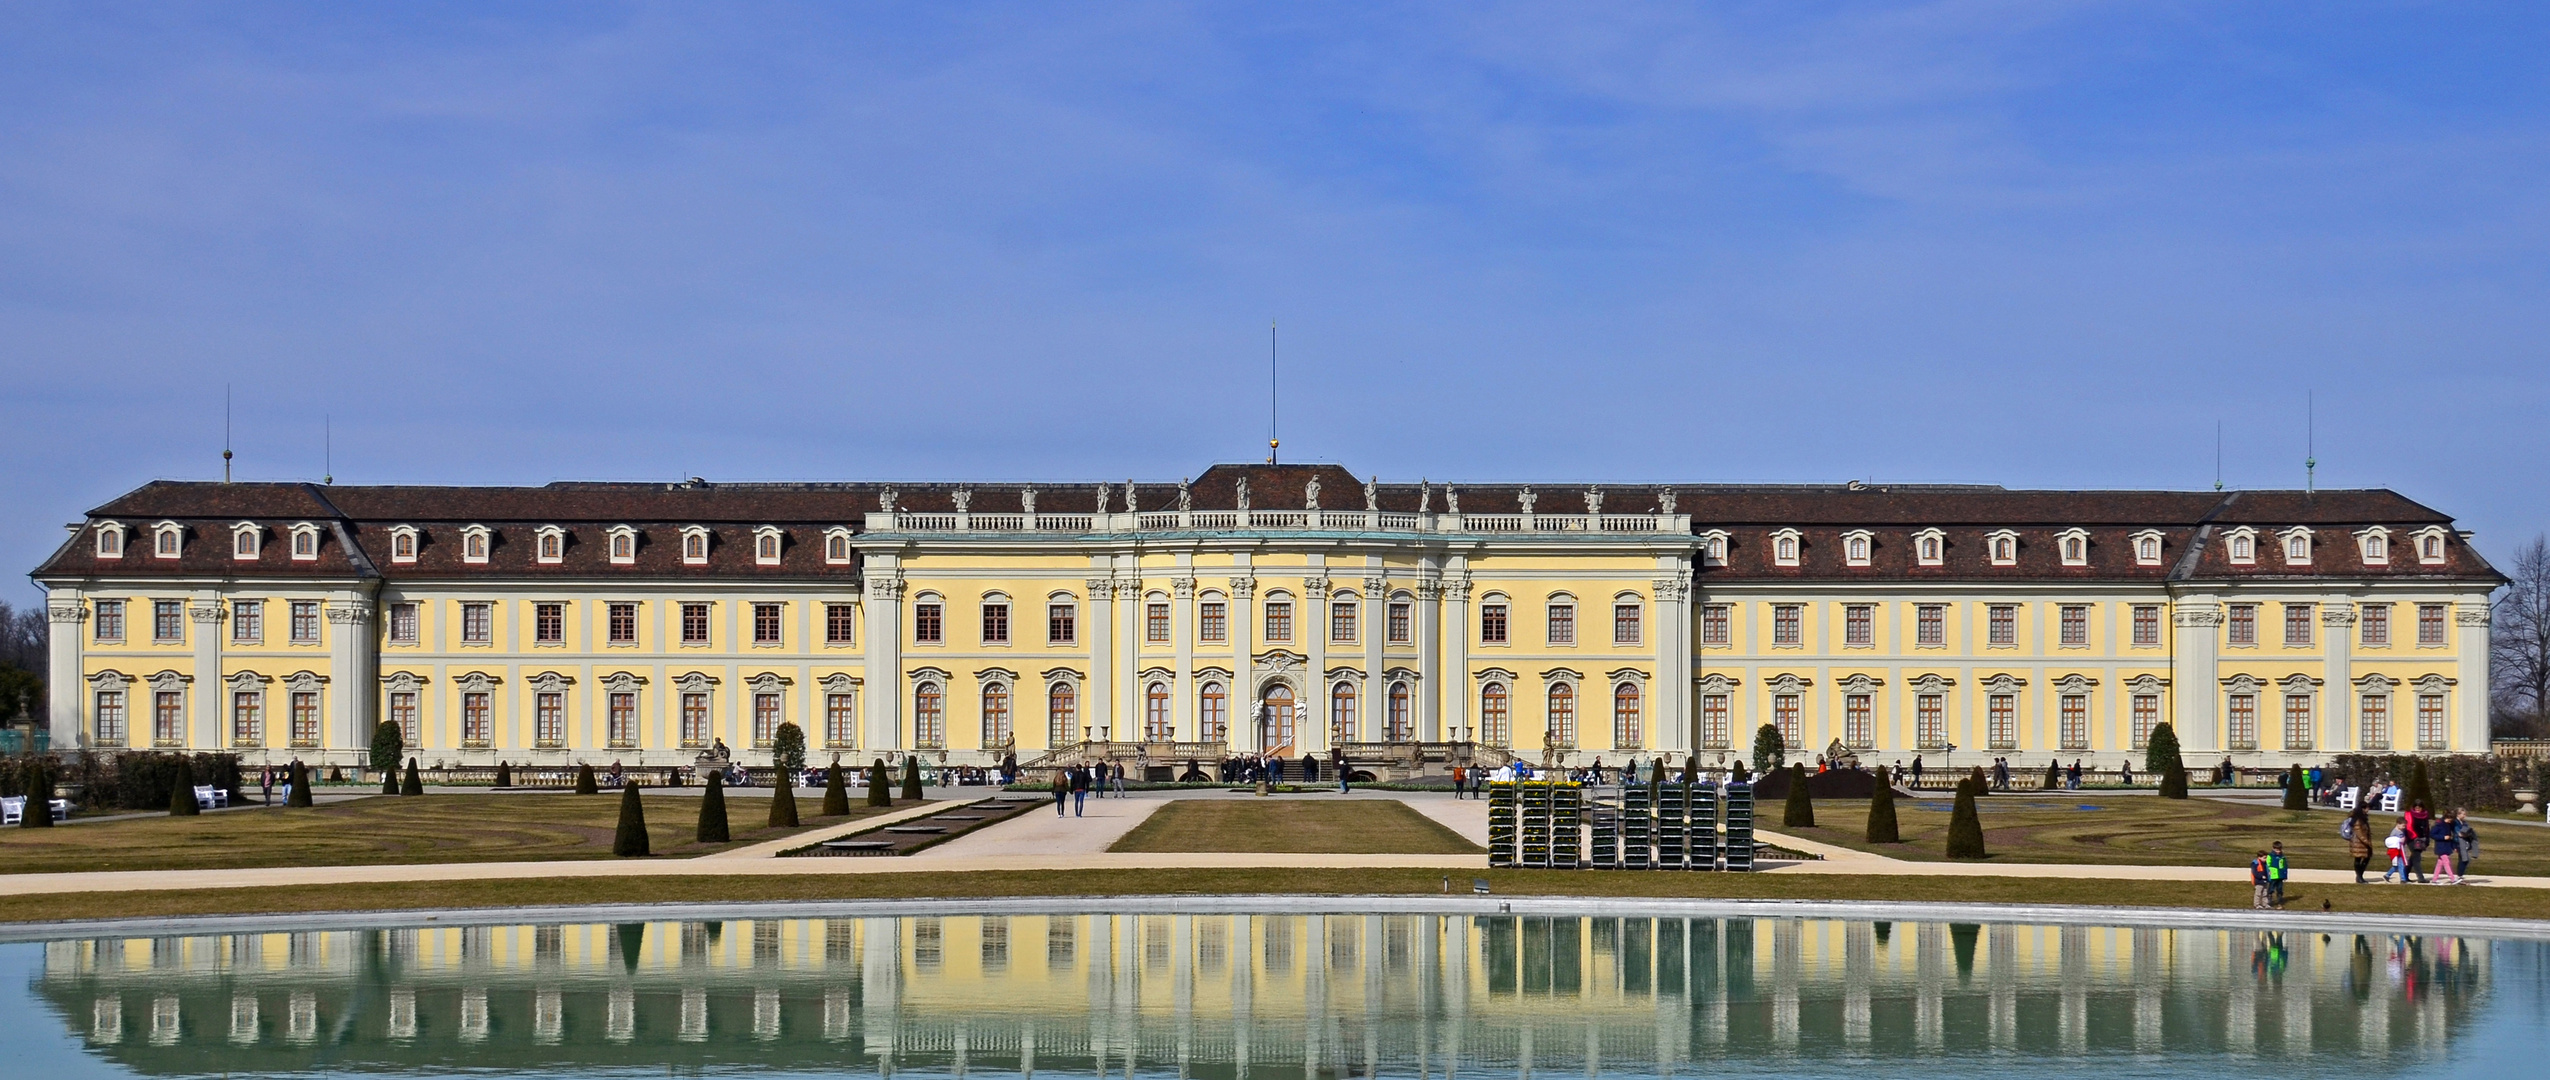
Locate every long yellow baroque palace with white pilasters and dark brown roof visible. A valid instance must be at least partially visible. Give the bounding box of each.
[33,466,2504,767]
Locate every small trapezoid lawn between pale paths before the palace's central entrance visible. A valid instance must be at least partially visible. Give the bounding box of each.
[1107,800,1484,856]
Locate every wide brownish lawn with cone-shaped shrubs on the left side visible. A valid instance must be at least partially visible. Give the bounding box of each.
[0,792,908,874]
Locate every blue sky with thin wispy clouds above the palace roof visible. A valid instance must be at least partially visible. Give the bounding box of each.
[0,0,2550,601]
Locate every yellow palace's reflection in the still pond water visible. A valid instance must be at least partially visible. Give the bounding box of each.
[36,914,2489,1075]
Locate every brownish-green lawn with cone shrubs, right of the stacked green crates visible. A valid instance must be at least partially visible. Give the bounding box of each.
[1760,792,2550,876]
